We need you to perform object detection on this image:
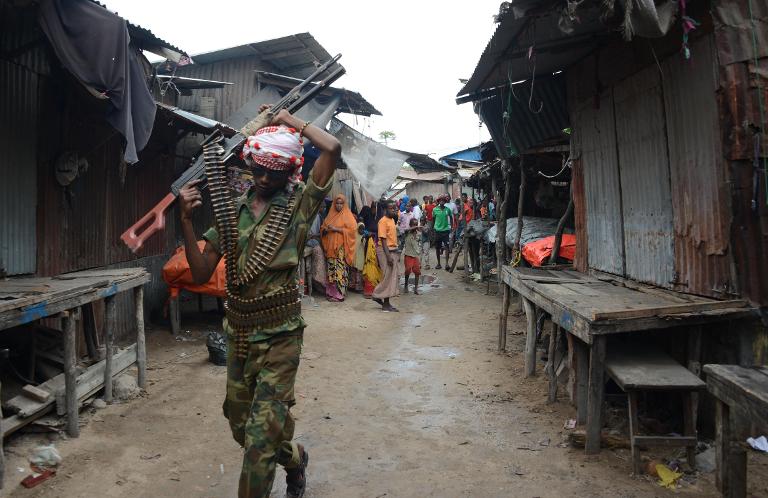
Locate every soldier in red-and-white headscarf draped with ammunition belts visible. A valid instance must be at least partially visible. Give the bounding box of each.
[179,109,341,498]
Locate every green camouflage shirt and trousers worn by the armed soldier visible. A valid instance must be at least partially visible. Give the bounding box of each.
[203,172,333,497]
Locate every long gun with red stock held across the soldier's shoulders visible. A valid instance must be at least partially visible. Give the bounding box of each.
[120,54,346,253]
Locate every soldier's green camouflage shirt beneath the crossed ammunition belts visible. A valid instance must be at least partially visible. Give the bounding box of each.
[203,173,333,342]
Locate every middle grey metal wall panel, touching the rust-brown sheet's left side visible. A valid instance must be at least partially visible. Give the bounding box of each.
[614,66,675,287]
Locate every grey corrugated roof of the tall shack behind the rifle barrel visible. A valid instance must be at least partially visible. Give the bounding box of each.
[193,33,339,79]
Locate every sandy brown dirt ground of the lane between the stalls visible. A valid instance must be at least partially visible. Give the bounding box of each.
[6,271,768,498]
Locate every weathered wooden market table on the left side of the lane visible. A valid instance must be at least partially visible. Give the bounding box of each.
[0,268,149,487]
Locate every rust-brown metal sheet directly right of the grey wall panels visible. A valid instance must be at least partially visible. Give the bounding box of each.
[661,36,737,297]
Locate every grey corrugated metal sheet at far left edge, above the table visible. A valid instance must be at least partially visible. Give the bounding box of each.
[0,60,40,275]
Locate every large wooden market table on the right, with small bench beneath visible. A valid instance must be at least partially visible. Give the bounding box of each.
[499,266,756,454]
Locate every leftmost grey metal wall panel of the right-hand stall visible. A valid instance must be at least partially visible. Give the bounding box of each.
[572,92,624,275]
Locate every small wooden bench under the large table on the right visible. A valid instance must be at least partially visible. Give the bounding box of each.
[605,348,706,475]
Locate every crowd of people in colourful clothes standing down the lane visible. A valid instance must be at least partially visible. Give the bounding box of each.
[307,194,496,312]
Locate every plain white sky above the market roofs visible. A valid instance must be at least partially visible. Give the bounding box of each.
[101,0,500,156]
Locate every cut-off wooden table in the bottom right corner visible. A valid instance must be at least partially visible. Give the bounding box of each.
[704,365,768,498]
